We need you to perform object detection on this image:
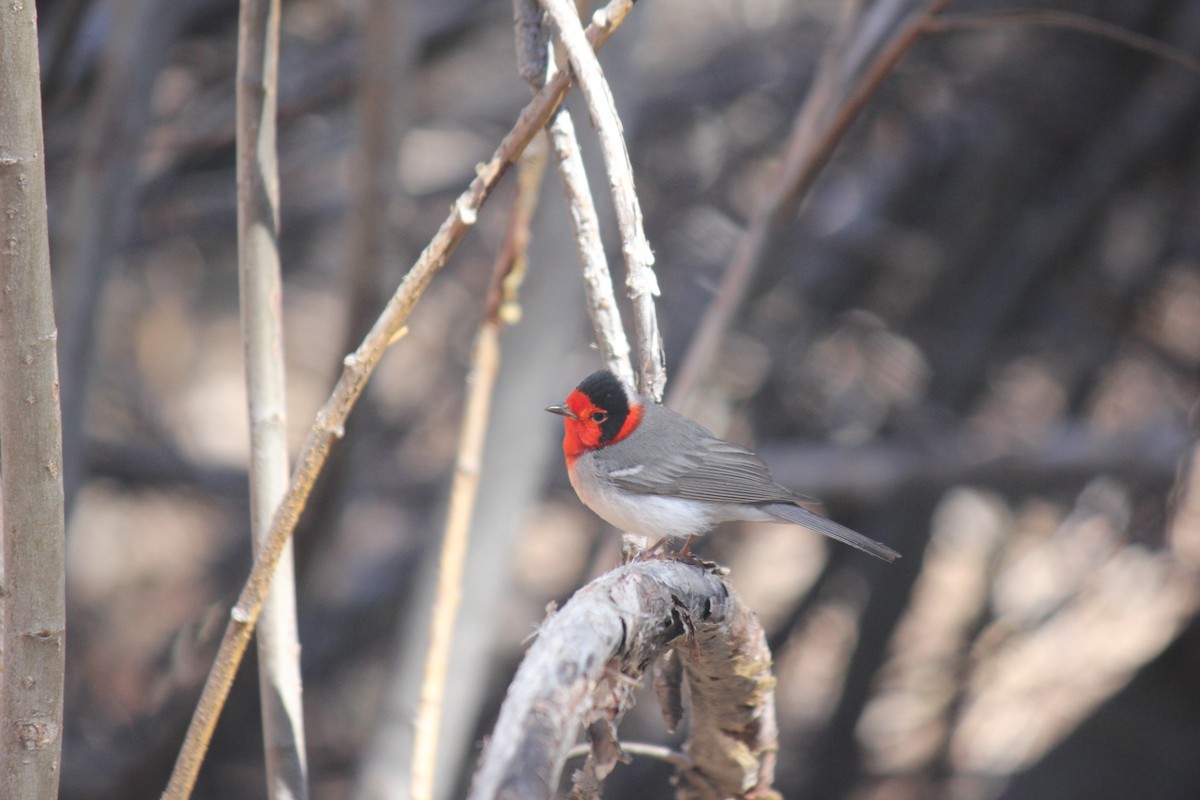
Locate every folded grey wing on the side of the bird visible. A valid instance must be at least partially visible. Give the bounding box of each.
[608,435,810,503]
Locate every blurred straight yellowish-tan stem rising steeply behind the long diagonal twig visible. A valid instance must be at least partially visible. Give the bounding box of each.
[409,144,546,800]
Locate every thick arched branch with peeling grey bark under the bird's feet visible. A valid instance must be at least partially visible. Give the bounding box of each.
[468,560,775,800]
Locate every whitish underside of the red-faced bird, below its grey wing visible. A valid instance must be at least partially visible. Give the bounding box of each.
[571,475,718,537]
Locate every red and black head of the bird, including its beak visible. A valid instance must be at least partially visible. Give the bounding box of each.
[546,369,643,467]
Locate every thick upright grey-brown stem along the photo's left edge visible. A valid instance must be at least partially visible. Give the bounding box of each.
[0,2,66,800]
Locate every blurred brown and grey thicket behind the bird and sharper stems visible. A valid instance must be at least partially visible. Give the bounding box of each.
[38,0,1200,800]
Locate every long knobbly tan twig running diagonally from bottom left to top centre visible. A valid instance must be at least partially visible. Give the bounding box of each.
[163,0,648,800]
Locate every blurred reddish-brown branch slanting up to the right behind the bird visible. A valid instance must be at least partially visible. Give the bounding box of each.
[668,0,950,410]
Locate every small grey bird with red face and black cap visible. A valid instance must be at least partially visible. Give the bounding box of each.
[546,369,900,561]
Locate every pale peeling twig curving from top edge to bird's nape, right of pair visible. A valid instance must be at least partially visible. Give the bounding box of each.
[539,0,667,401]
